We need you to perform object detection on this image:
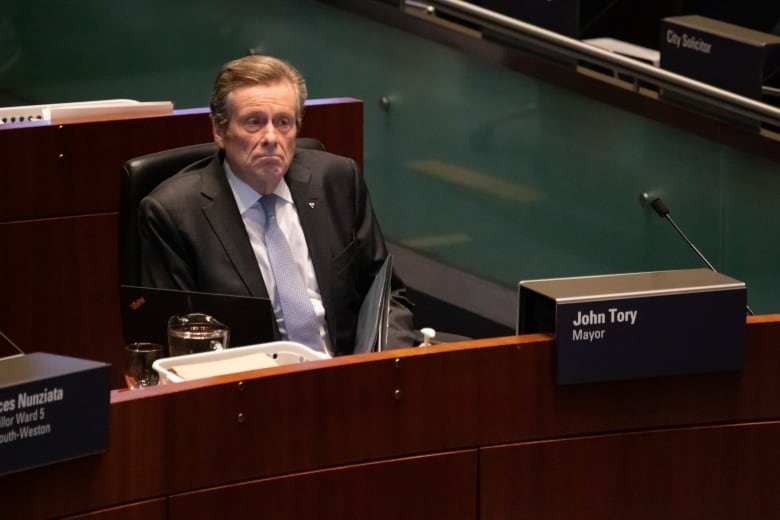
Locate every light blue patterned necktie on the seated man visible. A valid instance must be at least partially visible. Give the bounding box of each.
[260,193,323,351]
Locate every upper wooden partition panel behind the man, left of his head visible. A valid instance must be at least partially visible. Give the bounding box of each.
[0,111,211,222]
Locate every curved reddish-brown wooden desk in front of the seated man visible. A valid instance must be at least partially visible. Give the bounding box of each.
[0,315,780,520]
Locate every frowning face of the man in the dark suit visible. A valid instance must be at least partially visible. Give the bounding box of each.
[212,81,298,194]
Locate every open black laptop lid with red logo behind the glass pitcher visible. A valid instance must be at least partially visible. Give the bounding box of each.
[119,285,278,354]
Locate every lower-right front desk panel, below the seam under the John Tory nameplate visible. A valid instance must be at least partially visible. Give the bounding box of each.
[479,421,780,520]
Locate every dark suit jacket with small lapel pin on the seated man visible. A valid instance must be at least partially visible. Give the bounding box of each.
[139,150,415,355]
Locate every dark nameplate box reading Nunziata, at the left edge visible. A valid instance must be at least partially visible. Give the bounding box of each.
[0,352,111,475]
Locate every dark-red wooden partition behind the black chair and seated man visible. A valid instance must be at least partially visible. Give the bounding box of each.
[0,98,363,388]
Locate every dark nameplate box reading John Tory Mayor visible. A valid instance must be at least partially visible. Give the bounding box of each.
[518,269,747,384]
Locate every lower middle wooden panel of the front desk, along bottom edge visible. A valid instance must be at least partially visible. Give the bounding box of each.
[169,448,477,520]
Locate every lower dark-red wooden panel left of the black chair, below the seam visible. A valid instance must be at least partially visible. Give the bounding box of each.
[0,213,125,360]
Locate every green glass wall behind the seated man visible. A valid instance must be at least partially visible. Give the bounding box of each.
[6,0,780,313]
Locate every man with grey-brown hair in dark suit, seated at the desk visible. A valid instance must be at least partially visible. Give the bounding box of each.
[139,55,415,355]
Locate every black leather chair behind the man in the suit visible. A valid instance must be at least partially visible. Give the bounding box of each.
[119,137,325,285]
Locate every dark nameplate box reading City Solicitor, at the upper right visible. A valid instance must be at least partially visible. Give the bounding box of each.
[659,15,780,100]
